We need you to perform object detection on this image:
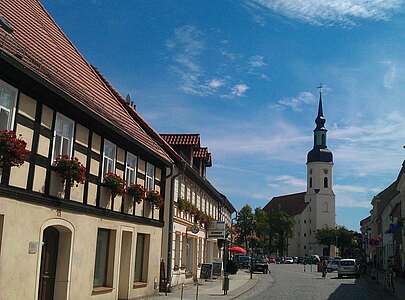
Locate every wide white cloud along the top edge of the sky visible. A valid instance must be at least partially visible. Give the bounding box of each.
[245,0,403,25]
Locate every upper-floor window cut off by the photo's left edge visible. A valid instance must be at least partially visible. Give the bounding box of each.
[0,80,17,130]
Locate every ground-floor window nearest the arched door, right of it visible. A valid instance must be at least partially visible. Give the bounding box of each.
[93,228,110,287]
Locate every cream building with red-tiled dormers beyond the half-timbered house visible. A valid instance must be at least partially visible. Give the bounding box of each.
[162,134,235,286]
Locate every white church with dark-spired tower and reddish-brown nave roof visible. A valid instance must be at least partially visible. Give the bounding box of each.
[264,92,336,256]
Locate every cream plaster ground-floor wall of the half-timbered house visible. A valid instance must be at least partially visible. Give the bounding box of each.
[0,198,162,300]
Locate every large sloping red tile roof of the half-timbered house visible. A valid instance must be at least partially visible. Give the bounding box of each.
[0,0,171,162]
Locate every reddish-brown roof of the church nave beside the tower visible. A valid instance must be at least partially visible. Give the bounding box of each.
[263,192,308,216]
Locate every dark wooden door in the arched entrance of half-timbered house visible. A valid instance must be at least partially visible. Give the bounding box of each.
[38,227,59,300]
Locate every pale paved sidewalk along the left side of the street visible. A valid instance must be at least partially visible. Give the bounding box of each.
[147,270,258,300]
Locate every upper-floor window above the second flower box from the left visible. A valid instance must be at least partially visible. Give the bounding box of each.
[53,113,75,161]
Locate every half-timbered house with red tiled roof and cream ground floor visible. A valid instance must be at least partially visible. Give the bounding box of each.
[0,0,172,300]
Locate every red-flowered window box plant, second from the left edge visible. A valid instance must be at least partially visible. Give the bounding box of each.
[54,155,86,187]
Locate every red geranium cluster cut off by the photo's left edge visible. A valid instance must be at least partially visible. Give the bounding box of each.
[0,130,30,167]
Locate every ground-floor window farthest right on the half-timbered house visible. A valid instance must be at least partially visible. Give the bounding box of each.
[134,233,149,282]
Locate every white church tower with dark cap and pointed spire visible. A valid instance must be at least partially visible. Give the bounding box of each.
[304,91,336,255]
